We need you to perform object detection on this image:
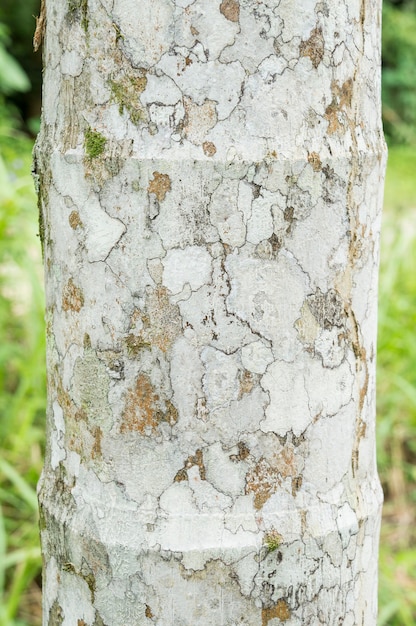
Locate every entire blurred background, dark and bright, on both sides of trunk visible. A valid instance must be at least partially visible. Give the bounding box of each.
[0,0,416,626]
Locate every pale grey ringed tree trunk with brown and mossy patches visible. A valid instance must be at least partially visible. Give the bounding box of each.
[35,0,385,626]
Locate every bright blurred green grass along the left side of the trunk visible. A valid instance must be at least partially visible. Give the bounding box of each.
[0,75,45,626]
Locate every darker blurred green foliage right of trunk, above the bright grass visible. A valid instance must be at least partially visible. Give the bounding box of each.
[382,0,416,144]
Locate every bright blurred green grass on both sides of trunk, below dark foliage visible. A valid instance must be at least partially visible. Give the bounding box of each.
[0,129,416,626]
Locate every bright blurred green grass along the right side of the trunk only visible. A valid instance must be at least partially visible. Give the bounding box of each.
[377,148,416,626]
